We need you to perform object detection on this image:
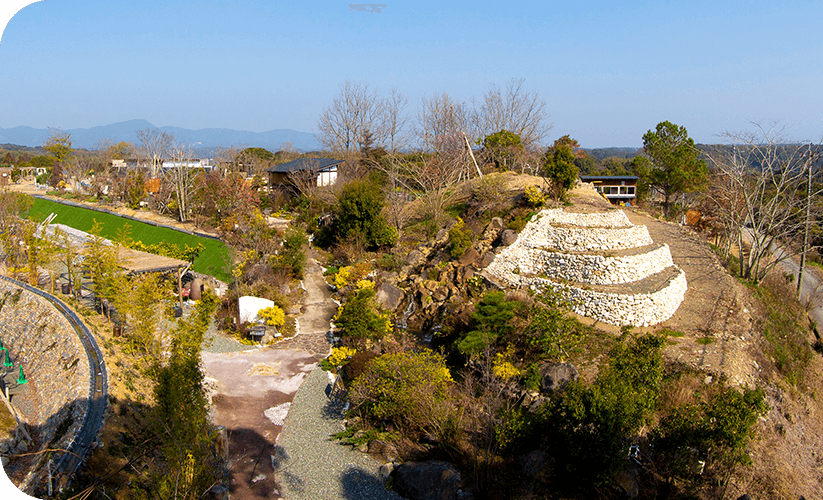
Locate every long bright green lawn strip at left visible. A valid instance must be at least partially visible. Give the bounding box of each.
[29,198,230,281]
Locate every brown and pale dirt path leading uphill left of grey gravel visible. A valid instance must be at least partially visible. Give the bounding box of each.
[202,259,337,499]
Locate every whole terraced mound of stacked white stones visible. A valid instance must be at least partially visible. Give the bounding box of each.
[486,209,687,326]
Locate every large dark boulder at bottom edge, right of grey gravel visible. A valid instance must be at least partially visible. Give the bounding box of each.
[394,460,462,500]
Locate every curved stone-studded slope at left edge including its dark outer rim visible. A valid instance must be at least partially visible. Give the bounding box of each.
[0,276,108,492]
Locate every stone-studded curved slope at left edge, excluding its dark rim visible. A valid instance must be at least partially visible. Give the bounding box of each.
[0,280,91,454]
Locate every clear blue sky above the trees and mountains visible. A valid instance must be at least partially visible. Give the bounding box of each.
[0,0,823,147]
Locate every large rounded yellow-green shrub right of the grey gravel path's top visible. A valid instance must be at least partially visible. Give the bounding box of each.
[349,350,454,430]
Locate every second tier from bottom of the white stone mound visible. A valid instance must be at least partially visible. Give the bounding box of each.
[488,244,673,285]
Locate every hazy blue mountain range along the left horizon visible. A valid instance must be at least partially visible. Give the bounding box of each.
[0,120,322,152]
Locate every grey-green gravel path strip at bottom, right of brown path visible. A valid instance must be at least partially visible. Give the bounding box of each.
[275,368,403,500]
